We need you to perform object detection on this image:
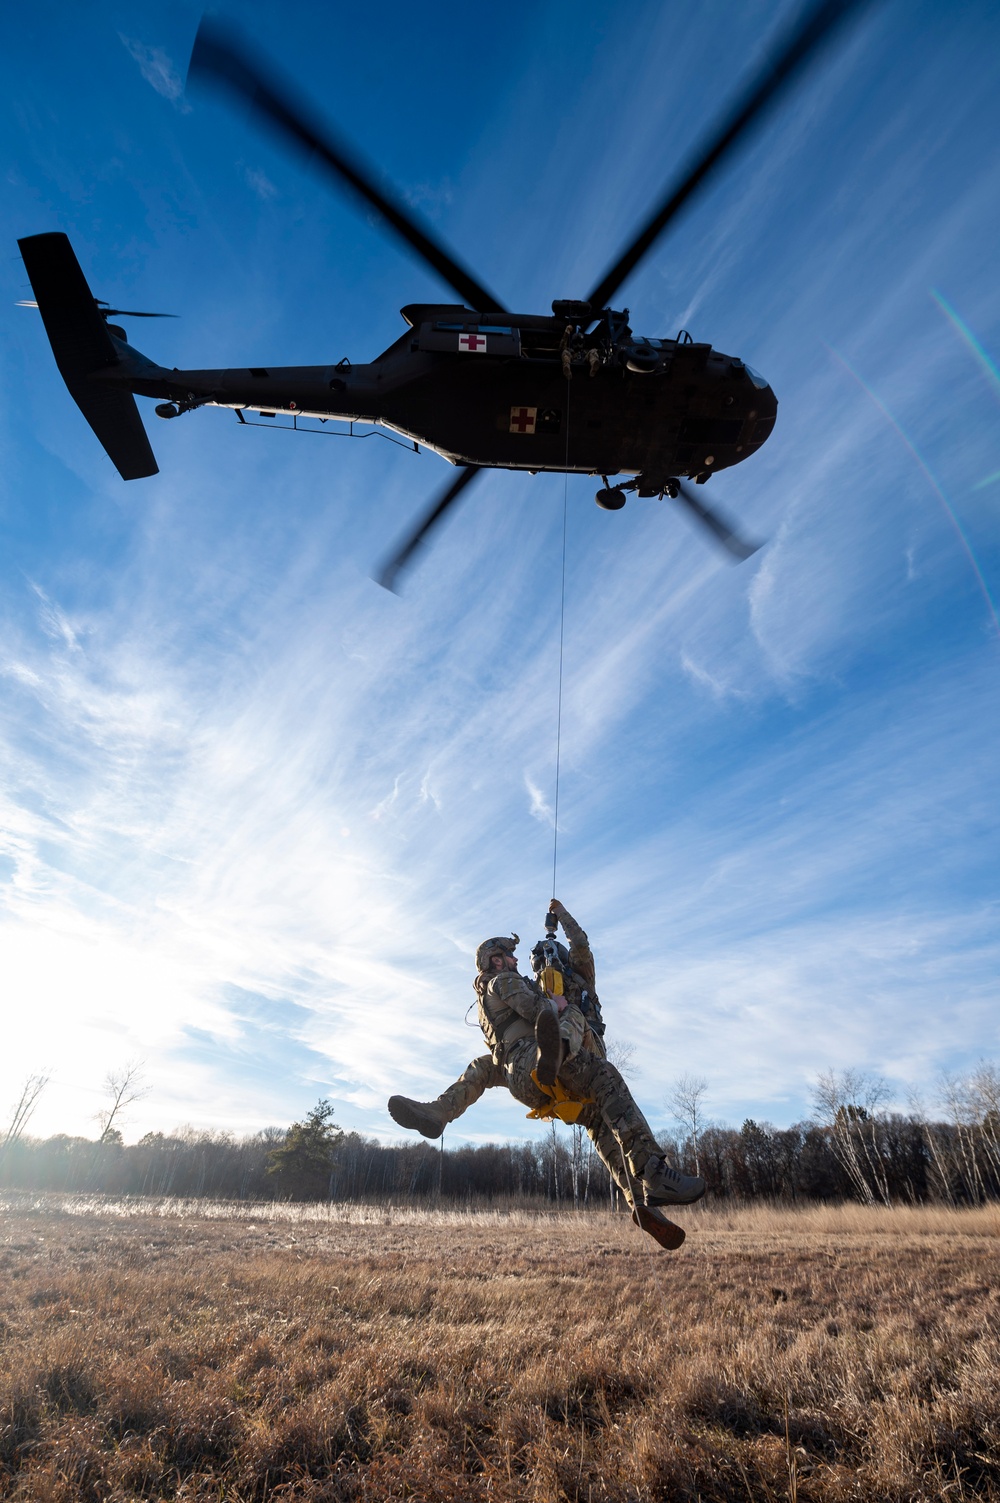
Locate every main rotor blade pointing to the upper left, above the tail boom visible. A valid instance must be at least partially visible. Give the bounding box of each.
[188,20,507,313]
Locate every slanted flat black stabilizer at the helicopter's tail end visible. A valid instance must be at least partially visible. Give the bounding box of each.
[18,234,158,479]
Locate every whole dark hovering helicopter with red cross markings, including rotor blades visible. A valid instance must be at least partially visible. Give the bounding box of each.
[18,0,860,589]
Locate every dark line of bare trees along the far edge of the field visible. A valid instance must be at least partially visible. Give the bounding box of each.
[0,1066,1000,1207]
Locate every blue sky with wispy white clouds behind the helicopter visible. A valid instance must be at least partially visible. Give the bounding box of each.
[0,0,1000,1141]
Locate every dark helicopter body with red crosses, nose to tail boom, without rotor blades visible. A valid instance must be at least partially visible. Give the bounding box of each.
[111,293,777,485]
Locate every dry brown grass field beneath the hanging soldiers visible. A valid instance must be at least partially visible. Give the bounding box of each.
[0,1196,1000,1503]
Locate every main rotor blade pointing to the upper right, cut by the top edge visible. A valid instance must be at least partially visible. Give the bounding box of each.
[586,0,866,310]
